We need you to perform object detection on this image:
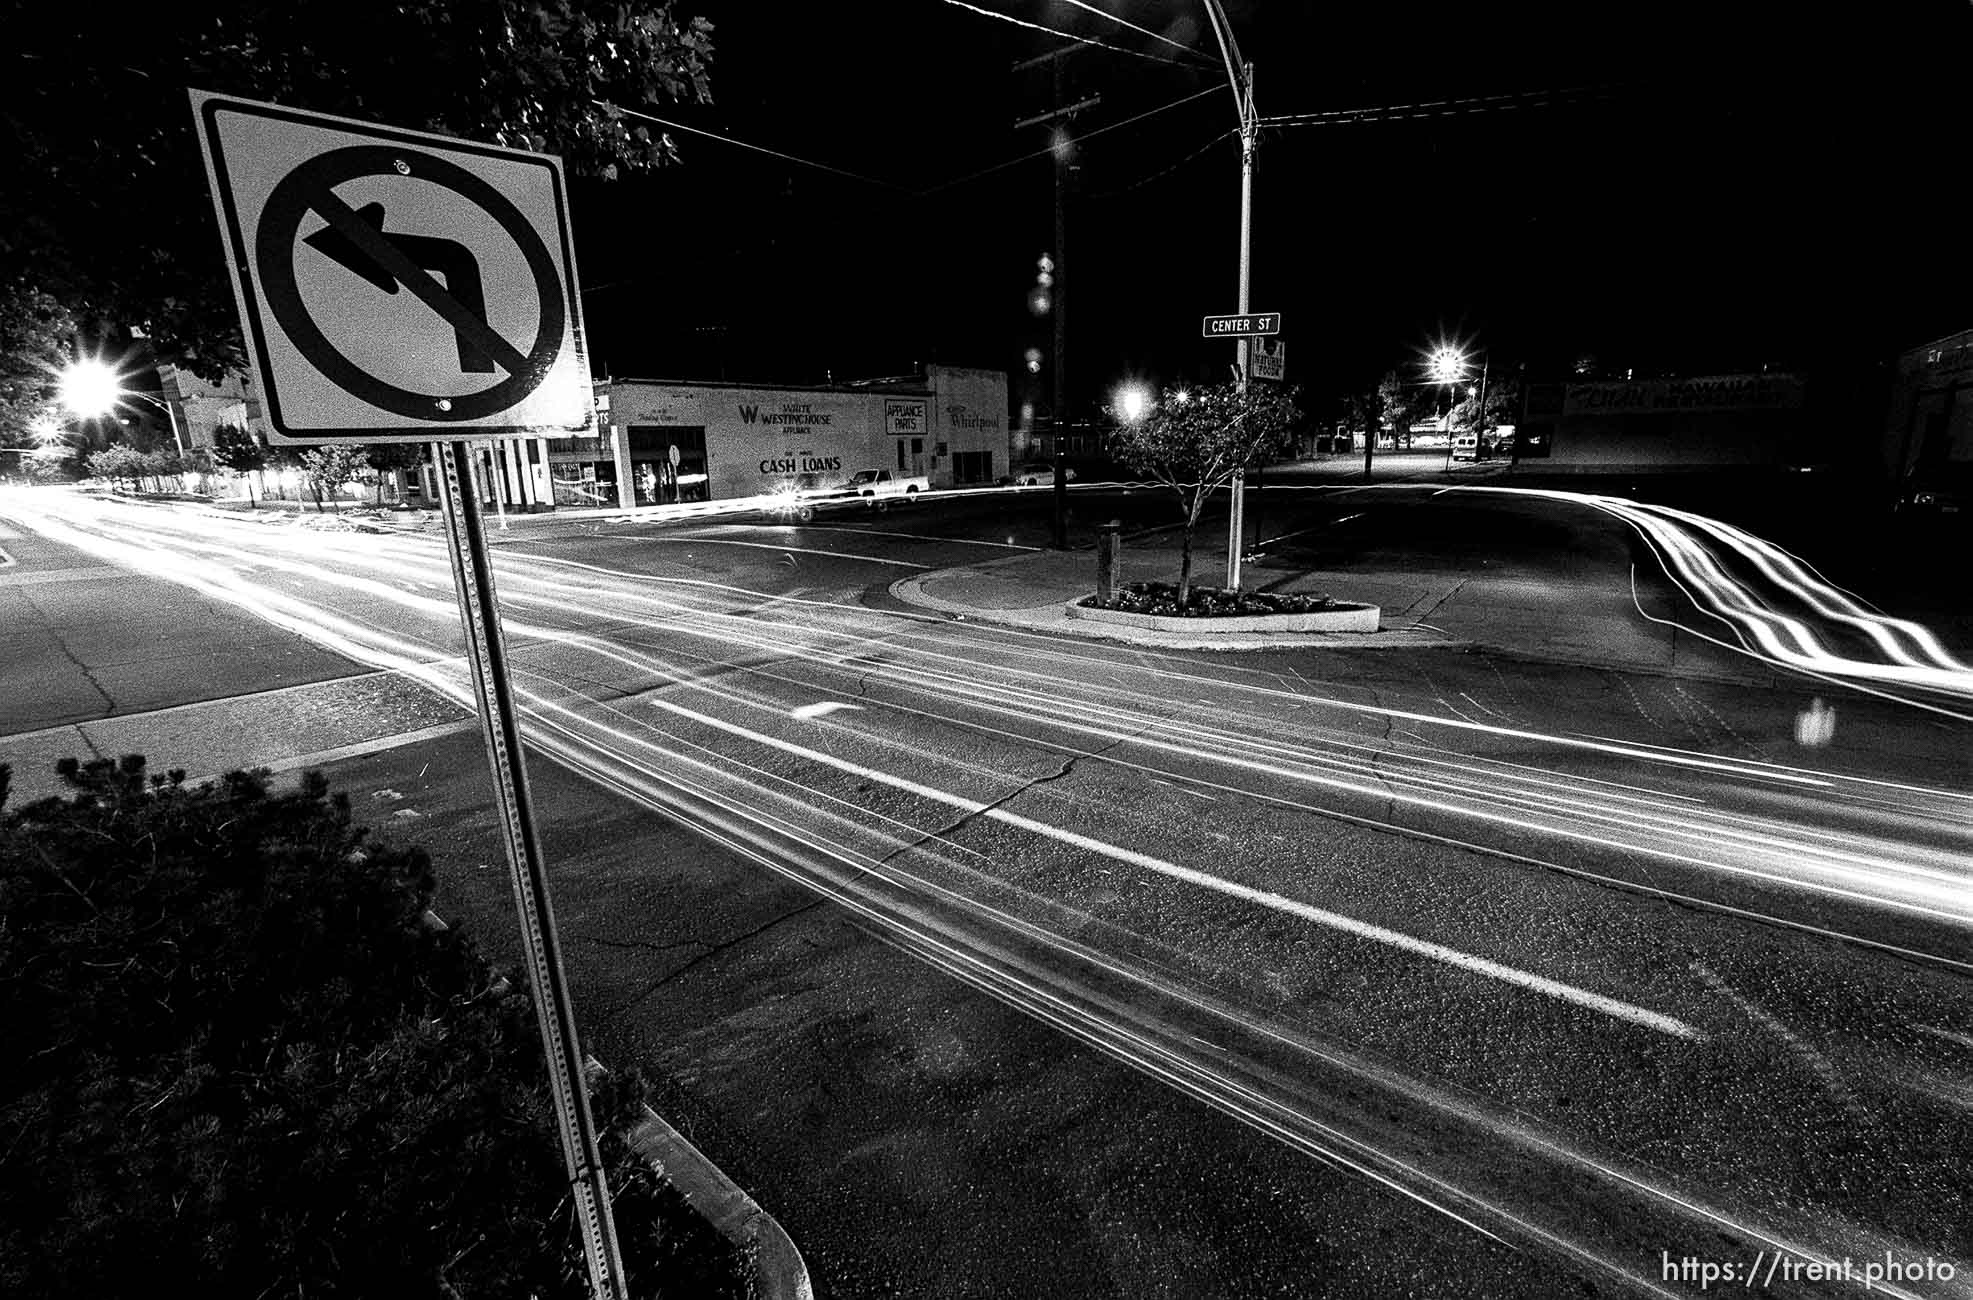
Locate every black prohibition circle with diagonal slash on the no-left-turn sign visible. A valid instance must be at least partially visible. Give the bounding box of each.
[255,146,568,422]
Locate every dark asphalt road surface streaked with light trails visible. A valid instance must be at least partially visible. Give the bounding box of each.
[10,489,1973,1296]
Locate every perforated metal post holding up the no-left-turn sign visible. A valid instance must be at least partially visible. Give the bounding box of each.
[438,442,629,1300]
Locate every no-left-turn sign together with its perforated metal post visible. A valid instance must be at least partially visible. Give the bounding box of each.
[191,91,629,1300]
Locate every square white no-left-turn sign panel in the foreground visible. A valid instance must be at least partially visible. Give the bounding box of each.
[191,91,594,446]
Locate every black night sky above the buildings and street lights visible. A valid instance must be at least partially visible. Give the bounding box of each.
[576,0,1973,416]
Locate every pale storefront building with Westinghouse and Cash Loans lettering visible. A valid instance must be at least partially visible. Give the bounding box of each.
[568,365,1010,509]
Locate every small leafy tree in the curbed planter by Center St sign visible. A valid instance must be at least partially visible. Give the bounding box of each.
[1109,383,1298,608]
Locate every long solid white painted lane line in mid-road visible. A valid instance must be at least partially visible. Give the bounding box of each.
[651,700,1703,1040]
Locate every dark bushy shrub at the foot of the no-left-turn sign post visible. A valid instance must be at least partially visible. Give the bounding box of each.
[0,756,741,1300]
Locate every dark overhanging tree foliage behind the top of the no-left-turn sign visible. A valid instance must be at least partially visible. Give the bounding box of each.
[0,0,712,379]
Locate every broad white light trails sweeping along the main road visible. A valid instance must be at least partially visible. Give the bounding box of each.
[7,493,1973,1294]
